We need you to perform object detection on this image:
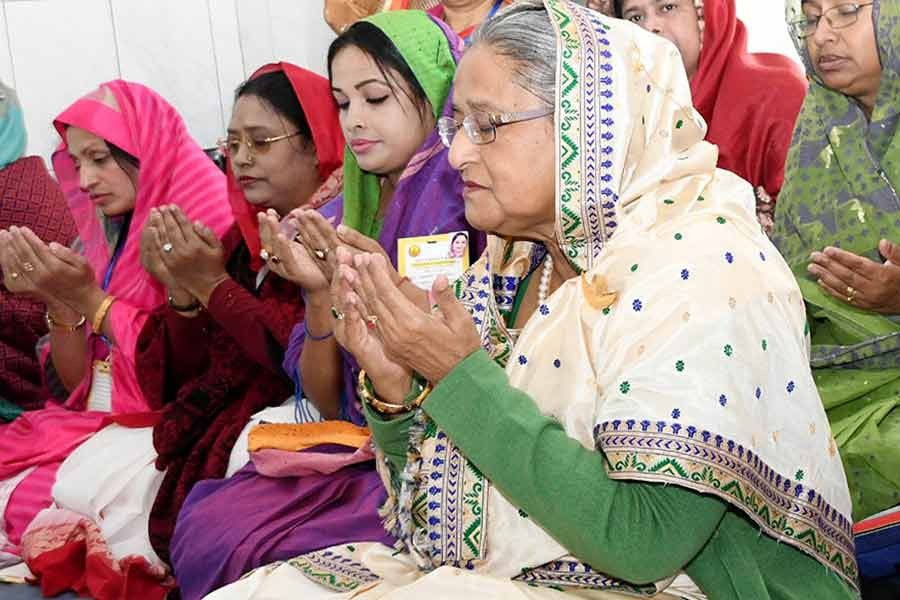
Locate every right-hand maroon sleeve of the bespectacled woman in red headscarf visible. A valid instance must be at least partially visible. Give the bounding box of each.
[207,275,303,375]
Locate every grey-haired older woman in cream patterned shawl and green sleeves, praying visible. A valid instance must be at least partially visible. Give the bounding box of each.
[212,0,857,599]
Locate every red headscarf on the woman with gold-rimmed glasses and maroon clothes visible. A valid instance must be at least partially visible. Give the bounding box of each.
[227,62,344,271]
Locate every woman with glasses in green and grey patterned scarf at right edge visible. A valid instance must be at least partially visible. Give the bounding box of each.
[773,0,900,520]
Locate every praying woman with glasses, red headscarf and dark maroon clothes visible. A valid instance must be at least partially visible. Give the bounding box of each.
[137,63,344,562]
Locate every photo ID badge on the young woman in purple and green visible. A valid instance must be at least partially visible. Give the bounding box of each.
[397,231,469,290]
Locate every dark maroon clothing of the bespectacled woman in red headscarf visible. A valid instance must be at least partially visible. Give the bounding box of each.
[136,226,303,562]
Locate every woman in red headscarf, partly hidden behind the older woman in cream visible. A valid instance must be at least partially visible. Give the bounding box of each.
[615,0,806,224]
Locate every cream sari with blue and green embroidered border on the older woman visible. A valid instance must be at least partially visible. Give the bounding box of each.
[206,0,856,598]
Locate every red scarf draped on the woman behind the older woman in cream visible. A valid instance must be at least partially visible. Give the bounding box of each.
[691,0,807,198]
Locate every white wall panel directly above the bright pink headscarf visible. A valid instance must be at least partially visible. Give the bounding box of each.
[112,0,223,146]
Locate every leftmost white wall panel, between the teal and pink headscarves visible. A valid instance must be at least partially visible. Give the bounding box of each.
[4,0,119,158]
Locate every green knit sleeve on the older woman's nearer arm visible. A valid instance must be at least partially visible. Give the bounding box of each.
[424,350,727,584]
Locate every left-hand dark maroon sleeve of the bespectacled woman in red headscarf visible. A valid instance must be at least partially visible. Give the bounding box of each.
[135,306,210,409]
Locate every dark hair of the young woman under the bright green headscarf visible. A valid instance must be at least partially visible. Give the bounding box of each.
[328,21,430,118]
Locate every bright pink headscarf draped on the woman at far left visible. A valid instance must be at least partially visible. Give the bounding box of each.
[53,80,233,413]
